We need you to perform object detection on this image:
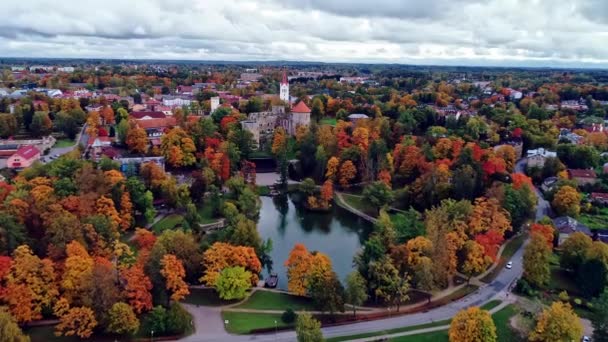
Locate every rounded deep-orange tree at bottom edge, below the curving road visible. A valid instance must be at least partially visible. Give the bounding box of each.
[448,306,497,342]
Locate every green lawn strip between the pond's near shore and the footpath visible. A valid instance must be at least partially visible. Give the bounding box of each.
[237,291,314,311]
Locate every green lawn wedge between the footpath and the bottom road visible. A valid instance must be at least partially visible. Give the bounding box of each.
[222,311,293,334]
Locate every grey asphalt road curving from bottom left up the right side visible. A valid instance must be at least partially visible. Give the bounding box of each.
[183,158,550,342]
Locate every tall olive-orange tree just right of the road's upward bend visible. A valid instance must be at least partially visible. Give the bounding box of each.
[523,233,552,287]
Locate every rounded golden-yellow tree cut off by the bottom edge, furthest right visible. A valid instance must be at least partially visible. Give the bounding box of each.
[529,301,583,342]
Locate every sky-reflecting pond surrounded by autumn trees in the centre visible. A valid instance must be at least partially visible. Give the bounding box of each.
[258,194,372,289]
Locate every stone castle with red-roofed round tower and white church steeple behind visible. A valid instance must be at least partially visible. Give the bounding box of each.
[241,71,310,146]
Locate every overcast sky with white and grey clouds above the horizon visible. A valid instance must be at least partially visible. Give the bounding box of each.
[0,0,608,67]
